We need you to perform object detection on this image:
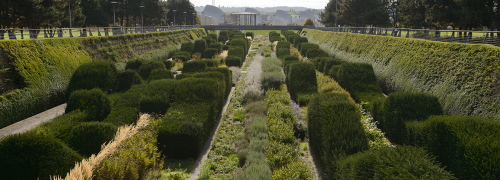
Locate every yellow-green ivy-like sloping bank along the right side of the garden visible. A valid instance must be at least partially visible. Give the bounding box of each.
[302,29,500,120]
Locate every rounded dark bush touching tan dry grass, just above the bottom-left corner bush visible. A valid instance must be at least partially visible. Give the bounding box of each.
[67,122,118,157]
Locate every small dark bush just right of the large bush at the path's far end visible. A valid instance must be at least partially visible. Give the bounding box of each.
[113,69,142,92]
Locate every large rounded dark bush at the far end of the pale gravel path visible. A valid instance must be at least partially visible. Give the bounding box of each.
[66,61,118,99]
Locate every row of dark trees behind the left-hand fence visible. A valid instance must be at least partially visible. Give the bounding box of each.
[0,0,201,29]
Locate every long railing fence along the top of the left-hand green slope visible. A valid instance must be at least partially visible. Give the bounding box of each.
[0,26,200,40]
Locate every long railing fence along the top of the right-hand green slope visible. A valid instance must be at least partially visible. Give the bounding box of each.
[308,27,500,46]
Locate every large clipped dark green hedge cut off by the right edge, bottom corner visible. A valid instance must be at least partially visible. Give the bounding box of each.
[407,116,500,179]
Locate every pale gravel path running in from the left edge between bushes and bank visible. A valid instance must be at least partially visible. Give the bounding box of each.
[0,103,66,141]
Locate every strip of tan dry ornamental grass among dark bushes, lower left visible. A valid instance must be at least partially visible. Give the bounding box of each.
[50,114,150,180]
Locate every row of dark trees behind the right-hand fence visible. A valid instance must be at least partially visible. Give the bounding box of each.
[321,0,500,30]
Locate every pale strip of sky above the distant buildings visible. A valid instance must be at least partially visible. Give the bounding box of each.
[190,0,328,9]
